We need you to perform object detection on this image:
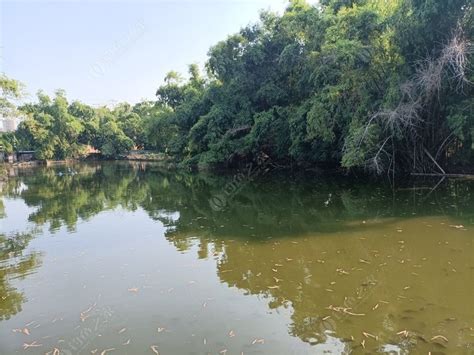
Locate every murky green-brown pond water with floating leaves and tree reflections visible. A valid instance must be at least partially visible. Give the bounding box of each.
[0,163,474,355]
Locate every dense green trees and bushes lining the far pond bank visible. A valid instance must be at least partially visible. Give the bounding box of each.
[0,0,474,174]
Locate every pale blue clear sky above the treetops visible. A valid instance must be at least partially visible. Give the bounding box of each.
[0,0,304,105]
